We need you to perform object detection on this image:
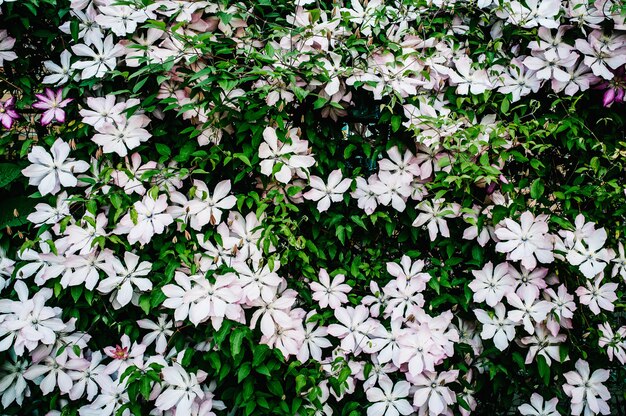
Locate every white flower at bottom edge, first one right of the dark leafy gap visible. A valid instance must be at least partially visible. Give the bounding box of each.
[365,376,413,416]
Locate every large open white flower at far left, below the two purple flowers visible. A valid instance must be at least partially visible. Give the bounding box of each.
[22,138,89,196]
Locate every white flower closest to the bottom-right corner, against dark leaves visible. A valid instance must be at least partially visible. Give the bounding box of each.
[563,359,611,416]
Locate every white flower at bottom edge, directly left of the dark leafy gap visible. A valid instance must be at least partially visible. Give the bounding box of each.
[155,363,204,415]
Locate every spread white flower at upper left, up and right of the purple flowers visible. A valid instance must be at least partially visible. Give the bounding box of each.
[72,35,124,79]
